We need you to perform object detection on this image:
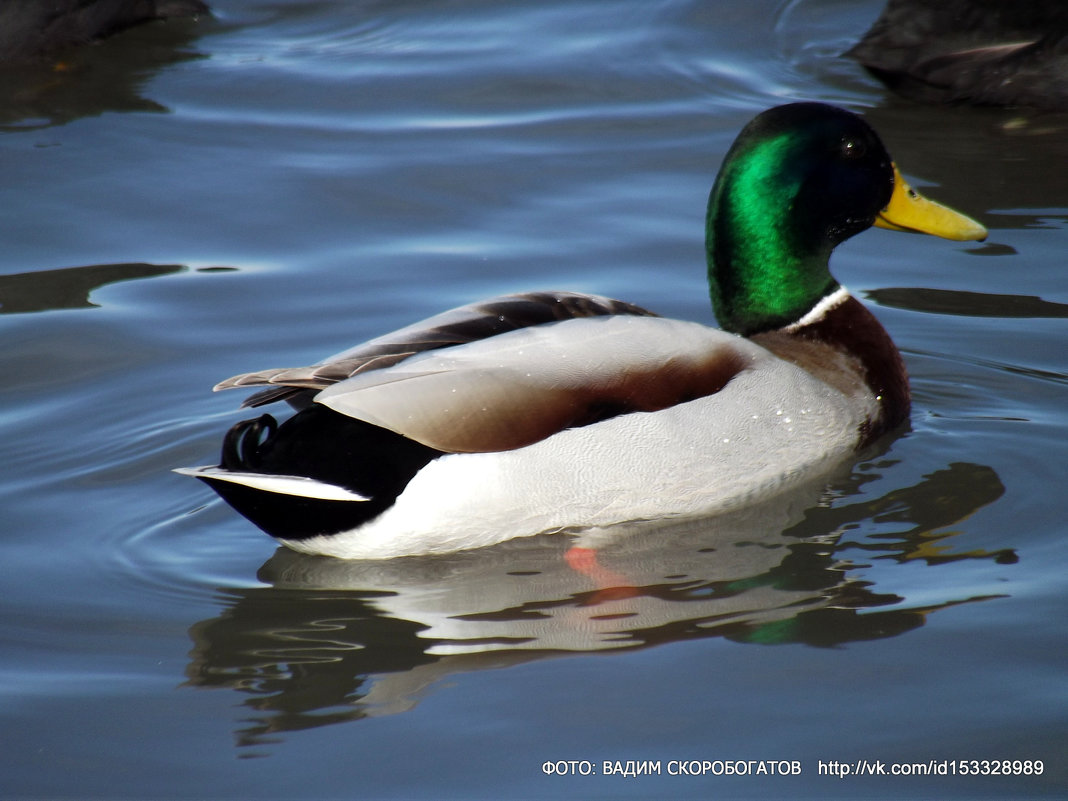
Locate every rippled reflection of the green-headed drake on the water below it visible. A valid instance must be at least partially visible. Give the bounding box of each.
[181,462,1016,756]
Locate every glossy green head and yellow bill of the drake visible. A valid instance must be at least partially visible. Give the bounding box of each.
[706,103,986,335]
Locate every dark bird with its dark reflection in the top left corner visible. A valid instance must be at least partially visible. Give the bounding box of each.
[0,0,209,128]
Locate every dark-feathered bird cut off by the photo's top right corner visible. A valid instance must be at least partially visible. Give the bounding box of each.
[846,0,1068,110]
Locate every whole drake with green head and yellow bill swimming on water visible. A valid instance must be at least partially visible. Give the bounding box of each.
[179,103,986,559]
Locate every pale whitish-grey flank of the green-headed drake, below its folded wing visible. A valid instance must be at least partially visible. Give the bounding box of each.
[281,332,877,559]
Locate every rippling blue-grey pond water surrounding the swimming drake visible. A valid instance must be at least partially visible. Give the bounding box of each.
[0,0,1068,799]
